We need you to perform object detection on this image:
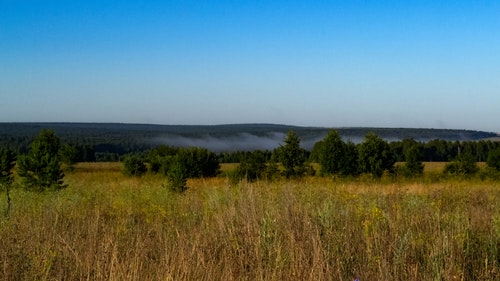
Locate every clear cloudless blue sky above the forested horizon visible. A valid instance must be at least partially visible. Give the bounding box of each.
[0,0,500,132]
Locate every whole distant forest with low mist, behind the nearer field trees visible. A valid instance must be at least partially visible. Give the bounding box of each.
[0,123,499,162]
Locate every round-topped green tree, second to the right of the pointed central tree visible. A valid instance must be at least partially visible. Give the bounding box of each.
[358,133,396,178]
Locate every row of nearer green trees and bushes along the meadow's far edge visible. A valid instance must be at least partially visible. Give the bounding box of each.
[0,129,500,206]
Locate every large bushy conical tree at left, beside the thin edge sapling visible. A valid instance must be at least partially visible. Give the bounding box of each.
[18,129,66,192]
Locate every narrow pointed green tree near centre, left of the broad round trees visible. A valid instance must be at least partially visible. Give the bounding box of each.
[277,131,306,178]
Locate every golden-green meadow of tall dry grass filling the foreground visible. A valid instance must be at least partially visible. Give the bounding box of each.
[0,163,500,281]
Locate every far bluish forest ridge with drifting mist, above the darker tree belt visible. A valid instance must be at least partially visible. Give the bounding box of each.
[0,123,499,152]
